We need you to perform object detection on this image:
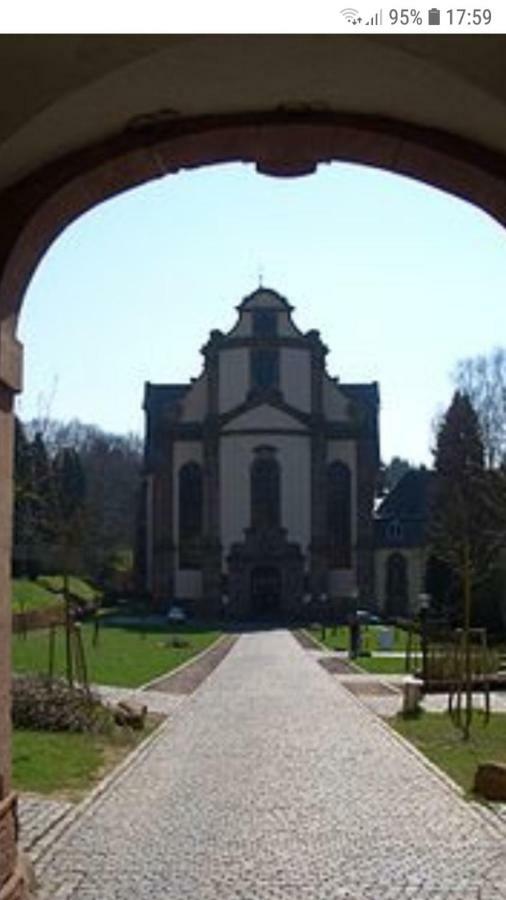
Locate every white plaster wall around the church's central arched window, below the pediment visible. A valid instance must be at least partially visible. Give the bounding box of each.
[220,435,311,556]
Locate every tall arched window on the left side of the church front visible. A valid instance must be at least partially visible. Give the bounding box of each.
[179,462,203,569]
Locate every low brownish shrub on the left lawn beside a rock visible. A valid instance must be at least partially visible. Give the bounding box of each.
[12,675,112,732]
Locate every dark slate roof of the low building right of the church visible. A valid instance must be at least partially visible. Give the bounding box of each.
[375,469,434,548]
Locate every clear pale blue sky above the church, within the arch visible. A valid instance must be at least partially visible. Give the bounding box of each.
[18,164,506,462]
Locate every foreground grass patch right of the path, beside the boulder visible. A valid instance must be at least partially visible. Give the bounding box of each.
[389,711,506,793]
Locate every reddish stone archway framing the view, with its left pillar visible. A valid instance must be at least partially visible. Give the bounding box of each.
[0,45,506,900]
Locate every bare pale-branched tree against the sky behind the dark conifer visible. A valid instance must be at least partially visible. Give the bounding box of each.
[454,347,506,468]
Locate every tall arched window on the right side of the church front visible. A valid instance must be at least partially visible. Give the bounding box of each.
[327,462,351,569]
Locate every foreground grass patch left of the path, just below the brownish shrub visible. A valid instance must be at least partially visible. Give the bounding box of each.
[12,717,161,800]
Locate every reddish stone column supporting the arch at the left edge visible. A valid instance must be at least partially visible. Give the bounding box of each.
[0,322,26,900]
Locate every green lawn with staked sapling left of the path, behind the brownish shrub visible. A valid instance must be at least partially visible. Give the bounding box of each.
[12,624,219,687]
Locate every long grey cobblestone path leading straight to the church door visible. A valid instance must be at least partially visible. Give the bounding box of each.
[39,631,506,900]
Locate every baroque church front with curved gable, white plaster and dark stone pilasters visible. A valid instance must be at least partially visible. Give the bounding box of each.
[143,287,379,619]
